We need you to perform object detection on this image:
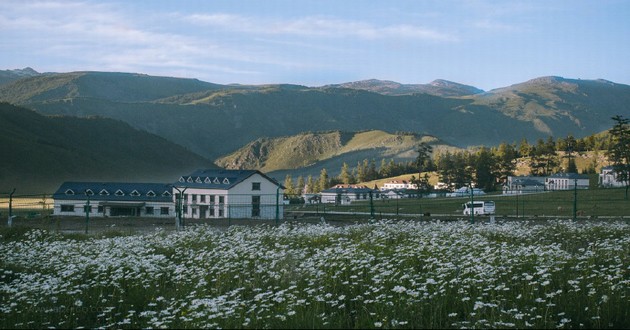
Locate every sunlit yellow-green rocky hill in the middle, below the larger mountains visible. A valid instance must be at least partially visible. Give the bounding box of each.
[216,130,455,177]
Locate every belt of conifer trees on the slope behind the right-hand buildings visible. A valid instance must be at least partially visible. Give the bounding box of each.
[284,116,630,195]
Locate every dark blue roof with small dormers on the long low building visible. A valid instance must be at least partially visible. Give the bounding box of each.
[53,182,172,202]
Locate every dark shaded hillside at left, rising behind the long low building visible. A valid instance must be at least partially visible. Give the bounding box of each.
[0,103,214,193]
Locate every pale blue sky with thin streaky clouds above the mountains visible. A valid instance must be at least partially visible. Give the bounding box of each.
[0,0,630,90]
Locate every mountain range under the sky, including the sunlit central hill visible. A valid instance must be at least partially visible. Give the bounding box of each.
[0,68,630,190]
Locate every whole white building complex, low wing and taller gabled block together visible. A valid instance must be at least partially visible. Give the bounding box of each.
[53,169,284,219]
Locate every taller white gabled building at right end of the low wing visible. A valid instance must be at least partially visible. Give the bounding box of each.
[173,169,284,219]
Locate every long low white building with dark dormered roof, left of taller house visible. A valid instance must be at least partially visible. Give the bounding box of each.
[53,182,175,218]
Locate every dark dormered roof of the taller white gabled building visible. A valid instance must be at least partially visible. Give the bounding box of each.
[173,169,284,190]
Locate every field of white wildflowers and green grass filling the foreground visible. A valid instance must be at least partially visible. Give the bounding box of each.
[0,221,630,328]
